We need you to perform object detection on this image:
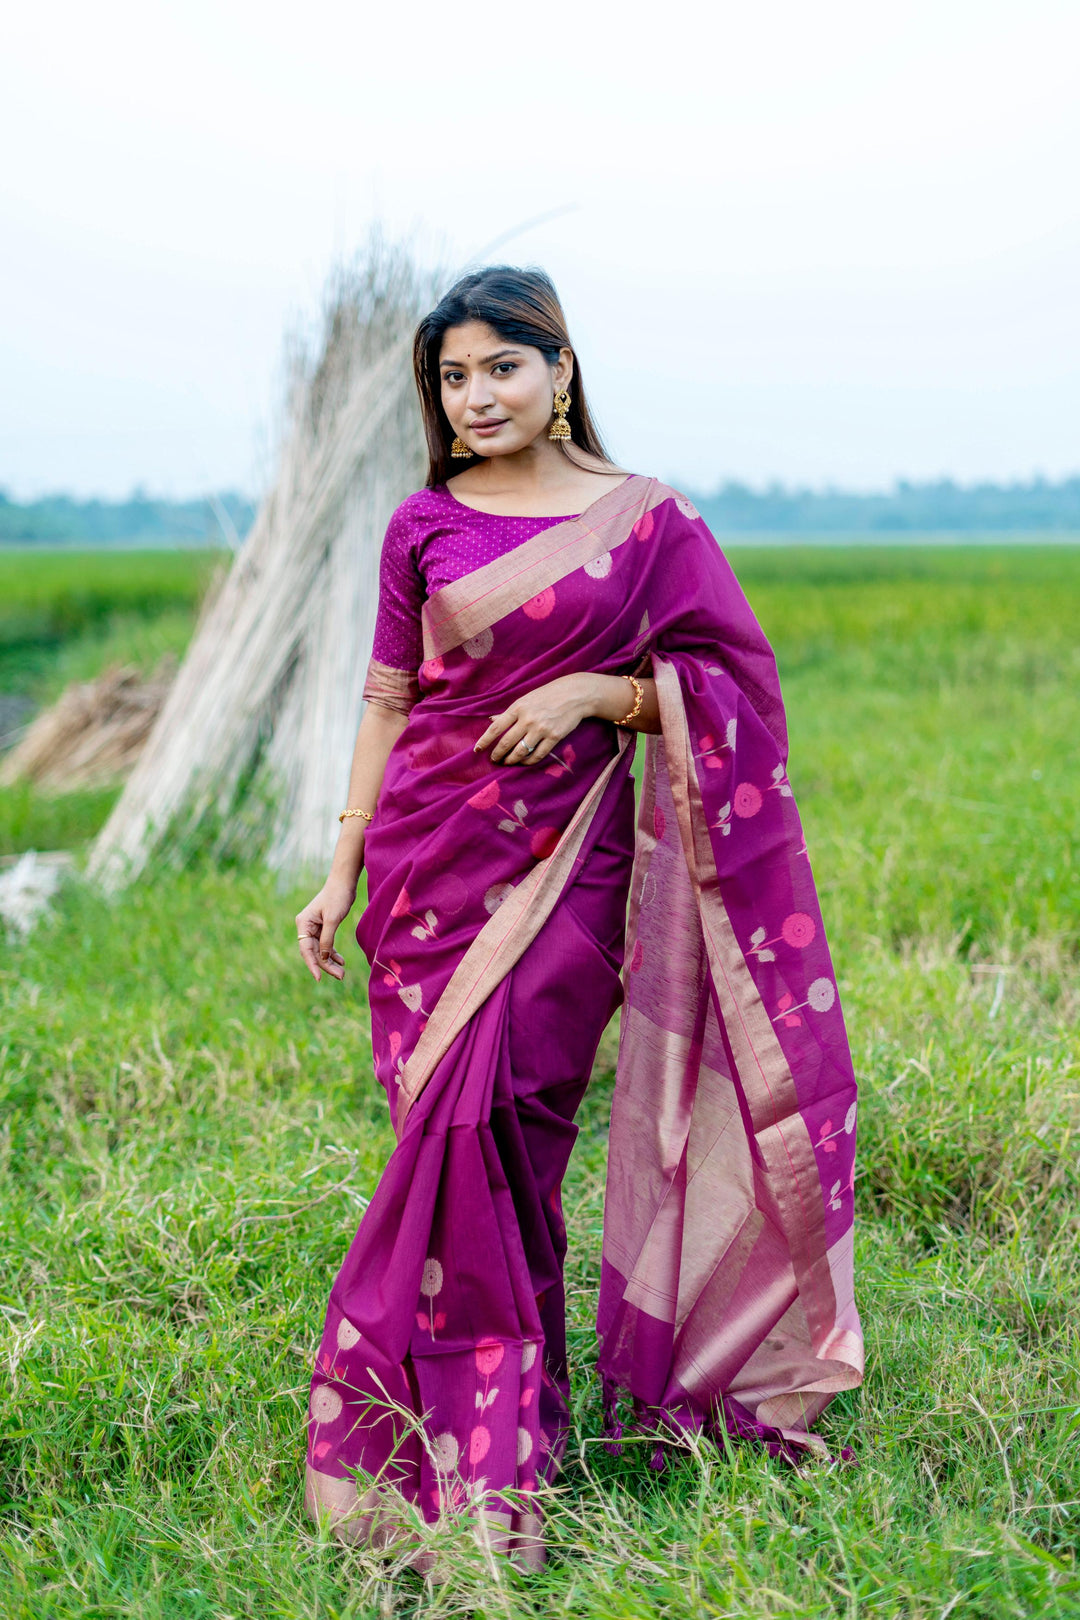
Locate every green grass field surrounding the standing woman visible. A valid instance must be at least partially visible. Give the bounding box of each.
[0,546,1080,1620]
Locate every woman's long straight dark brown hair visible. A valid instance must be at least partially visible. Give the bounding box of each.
[413,264,614,489]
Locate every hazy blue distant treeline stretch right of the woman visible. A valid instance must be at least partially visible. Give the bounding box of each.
[695,478,1080,535]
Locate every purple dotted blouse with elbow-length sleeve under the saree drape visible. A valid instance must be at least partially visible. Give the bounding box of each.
[371,484,576,672]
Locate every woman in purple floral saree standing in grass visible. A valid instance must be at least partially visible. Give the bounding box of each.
[296,267,861,1562]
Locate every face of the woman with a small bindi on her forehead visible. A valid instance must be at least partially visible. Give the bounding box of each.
[439,321,573,457]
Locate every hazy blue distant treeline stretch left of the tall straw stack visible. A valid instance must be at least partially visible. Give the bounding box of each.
[0,489,254,546]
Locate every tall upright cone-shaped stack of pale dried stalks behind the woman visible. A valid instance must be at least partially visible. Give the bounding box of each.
[89,238,434,888]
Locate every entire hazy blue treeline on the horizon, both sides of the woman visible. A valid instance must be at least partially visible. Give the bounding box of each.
[0,476,1080,546]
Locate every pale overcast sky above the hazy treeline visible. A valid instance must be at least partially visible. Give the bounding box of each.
[0,0,1080,496]
